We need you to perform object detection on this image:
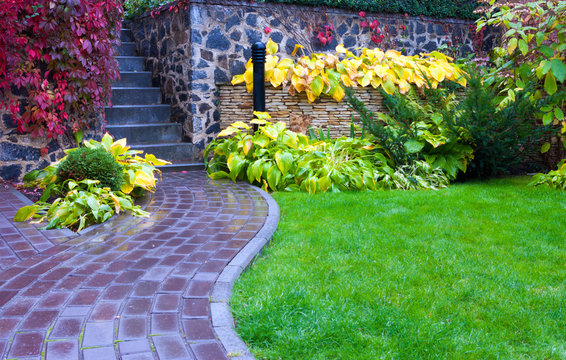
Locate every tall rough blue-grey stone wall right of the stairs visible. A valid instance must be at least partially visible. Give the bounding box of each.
[129,0,494,155]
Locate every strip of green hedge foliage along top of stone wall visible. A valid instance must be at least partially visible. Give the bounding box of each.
[260,0,479,19]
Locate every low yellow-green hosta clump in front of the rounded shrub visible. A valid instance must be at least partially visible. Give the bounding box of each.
[14,179,149,231]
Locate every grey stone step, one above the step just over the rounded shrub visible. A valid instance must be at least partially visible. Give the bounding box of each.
[104,105,171,125]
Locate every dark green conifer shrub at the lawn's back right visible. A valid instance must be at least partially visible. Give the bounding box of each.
[443,67,546,178]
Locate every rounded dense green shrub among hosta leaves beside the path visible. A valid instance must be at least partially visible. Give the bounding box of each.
[57,147,124,191]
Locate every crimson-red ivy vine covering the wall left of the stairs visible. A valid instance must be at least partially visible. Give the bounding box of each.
[0,0,123,138]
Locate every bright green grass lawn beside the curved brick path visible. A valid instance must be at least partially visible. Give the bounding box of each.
[231,178,566,359]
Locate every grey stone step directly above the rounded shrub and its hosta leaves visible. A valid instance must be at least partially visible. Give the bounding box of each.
[106,123,183,146]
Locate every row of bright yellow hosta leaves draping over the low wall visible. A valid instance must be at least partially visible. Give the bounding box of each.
[232,40,466,102]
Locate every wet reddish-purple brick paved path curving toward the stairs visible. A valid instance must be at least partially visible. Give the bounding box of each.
[0,172,274,360]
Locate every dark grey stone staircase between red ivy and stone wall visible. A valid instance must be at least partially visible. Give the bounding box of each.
[105,29,204,171]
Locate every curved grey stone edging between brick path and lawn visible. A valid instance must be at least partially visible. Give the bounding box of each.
[210,185,280,360]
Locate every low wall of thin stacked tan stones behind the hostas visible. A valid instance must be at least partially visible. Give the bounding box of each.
[219,84,386,137]
